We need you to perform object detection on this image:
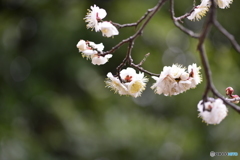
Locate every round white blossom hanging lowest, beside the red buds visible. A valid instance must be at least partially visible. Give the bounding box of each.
[197,99,228,124]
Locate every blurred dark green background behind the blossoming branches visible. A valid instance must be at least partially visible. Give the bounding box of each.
[0,0,240,160]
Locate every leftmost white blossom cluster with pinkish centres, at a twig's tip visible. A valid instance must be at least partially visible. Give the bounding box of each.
[77,40,112,65]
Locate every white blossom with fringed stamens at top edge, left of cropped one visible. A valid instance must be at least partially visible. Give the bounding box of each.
[187,0,211,21]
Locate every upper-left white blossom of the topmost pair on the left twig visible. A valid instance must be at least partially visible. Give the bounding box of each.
[84,4,107,32]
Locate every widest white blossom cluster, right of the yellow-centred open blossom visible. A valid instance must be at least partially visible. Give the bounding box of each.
[151,64,202,96]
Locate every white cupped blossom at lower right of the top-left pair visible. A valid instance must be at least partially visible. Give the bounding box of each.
[99,21,119,37]
